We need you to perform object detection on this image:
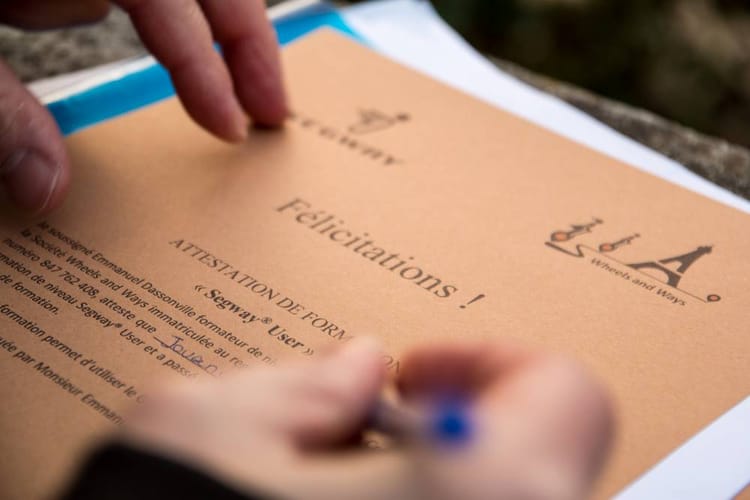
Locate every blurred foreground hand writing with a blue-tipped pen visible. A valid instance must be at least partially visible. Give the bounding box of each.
[116,340,612,500]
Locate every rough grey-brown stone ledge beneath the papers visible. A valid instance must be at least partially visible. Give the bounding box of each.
[0,6,750,199]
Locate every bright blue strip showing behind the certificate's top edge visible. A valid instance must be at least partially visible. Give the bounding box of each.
[47,5,362,135]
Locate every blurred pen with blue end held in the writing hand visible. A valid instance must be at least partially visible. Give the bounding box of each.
[369,399,474,445]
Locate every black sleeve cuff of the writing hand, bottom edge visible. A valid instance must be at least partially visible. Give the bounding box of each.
[61,444,271,500]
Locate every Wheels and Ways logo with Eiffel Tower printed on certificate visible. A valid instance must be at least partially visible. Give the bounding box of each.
[544,218,721,306]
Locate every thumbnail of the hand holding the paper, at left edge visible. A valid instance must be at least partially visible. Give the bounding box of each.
[0,150,60,212]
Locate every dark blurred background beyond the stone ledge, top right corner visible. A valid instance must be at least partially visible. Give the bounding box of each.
[346,0,750,146]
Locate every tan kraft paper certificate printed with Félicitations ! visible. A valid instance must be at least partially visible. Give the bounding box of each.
[0,31,750,498]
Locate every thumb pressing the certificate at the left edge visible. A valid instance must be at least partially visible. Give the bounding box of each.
[0,61,70,214]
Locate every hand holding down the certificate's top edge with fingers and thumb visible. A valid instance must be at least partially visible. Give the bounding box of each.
[0,0,287,213]
